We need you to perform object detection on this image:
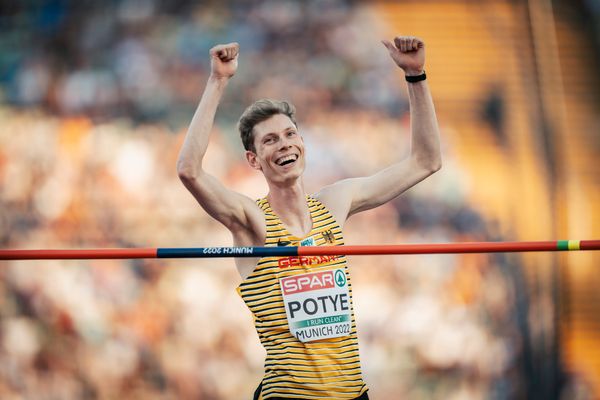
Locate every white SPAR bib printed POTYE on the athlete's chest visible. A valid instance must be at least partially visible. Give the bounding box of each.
[279,268,352,342]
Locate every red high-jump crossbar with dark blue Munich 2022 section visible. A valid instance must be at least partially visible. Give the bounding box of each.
[0,240,600,260]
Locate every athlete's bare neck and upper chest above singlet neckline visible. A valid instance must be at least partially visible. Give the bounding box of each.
[267,180,312,237]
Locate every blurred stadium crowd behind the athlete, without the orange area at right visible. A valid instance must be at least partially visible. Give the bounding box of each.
[0,0,592,400]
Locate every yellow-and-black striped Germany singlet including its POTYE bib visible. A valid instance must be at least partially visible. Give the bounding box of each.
[237,196,367,399]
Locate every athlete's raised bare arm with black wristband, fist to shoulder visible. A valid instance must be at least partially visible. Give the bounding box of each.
[318,37,441,223]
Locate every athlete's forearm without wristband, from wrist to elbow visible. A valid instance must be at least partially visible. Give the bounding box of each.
[177,76,228,176]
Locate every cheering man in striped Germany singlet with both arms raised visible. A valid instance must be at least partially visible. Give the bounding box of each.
[177,36,441,399]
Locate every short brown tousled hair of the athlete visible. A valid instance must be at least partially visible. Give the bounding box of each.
[238,99,298,152]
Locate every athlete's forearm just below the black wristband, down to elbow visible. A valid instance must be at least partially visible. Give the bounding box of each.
[408,80,442,171]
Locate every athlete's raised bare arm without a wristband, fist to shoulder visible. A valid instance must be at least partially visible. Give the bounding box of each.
[177,43,262,234]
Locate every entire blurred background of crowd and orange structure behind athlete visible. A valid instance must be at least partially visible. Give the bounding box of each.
[0,0,600,399]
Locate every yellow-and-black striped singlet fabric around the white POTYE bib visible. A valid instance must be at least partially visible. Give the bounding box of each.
[237,196,367,399]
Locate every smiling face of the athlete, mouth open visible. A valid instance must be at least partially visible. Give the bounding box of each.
[246,114,304,184]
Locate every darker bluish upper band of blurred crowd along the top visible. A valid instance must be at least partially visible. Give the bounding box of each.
[0,0,408,121]
